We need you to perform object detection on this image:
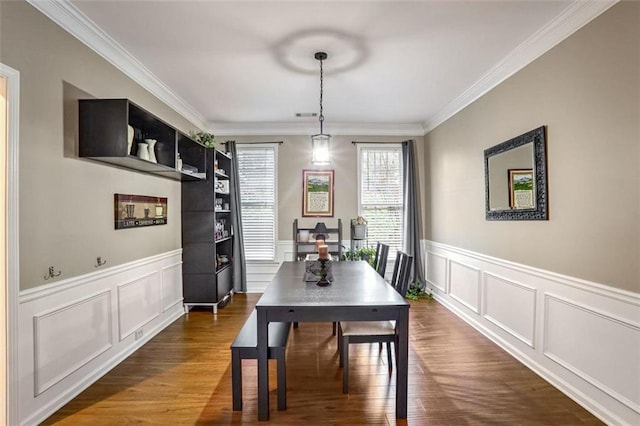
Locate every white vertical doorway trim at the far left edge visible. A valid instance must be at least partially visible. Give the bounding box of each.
[0,62,20,425]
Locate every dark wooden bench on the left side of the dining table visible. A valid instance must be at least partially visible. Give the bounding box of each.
[231,309,291,411]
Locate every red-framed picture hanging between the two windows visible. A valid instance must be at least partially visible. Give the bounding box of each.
[302,170,334,217]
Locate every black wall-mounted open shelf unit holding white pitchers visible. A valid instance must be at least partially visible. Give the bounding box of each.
[78,99,206,180]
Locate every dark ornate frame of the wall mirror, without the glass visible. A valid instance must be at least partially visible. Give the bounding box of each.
[484,126,549,220]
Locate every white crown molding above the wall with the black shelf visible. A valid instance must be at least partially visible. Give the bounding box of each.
[27,0,207,128]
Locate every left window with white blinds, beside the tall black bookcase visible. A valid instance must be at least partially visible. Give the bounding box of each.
[237,144,277,261]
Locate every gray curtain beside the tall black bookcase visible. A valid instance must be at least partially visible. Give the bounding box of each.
[227,141,247,292]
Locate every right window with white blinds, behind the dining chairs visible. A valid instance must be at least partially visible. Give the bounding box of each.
[358,144,404,252]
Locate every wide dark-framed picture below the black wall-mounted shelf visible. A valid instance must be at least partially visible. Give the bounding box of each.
[113,194,167,229]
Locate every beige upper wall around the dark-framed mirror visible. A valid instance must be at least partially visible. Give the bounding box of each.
[423,1,640,291]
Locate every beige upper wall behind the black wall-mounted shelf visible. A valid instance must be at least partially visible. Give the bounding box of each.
[0,1,200,290]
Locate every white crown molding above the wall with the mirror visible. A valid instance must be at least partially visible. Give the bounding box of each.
[422,0,619,133]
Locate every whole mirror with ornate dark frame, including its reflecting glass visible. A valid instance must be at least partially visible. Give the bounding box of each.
[484,126,548,220]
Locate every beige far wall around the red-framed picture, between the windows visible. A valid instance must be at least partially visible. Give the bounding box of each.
[224,135,424,241]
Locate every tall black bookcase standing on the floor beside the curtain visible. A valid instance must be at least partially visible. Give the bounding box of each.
[182,149,235,312]
